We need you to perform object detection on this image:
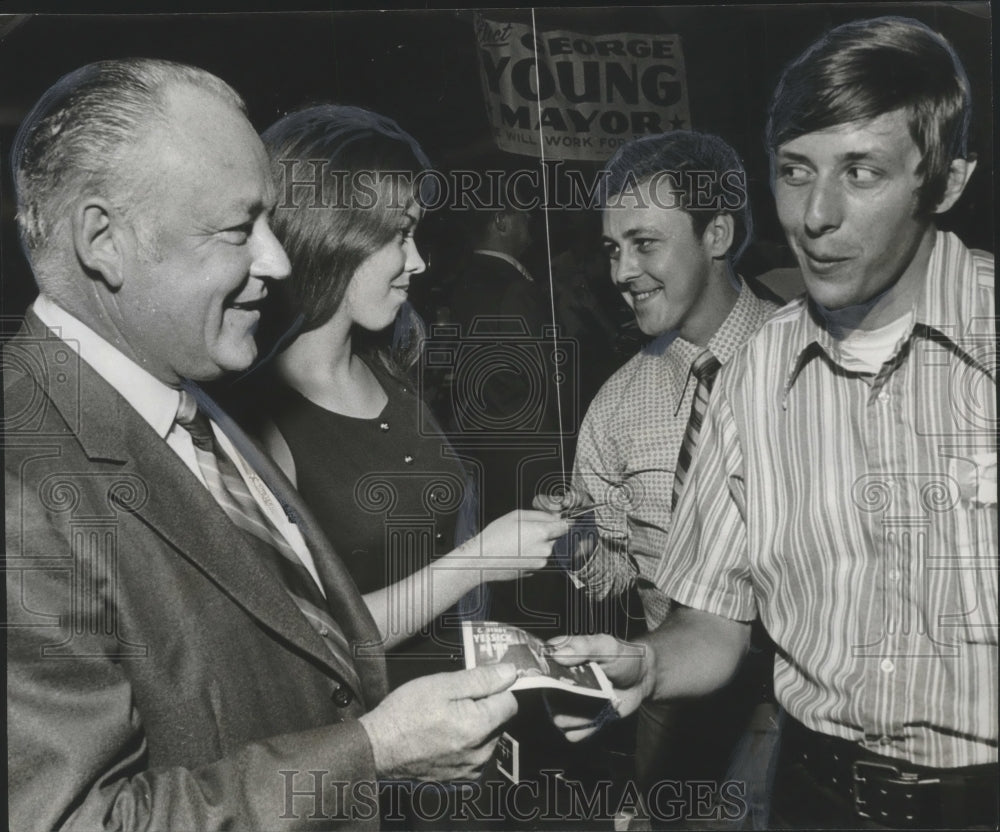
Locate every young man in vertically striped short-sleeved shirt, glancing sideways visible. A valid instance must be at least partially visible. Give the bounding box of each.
[556,18,998,828]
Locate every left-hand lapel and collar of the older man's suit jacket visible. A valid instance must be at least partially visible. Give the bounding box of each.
[8,311,370,680]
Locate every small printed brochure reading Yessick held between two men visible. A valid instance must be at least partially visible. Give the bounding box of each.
[462,621,616,700]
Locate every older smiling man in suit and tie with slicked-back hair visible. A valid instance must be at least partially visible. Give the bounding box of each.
[3,59,528,829]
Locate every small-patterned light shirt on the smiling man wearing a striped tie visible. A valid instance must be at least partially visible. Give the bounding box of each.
[573,281,778,627]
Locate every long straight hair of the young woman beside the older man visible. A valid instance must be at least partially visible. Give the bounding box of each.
[261,104,434,375]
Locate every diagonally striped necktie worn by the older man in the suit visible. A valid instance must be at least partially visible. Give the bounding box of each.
[177,390,361,690]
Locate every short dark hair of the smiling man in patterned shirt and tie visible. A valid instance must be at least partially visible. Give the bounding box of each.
[601,130,753,263]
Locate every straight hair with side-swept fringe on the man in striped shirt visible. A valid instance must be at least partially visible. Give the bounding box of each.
[766,17,972,213]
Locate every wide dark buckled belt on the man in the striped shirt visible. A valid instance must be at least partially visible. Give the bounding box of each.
[781,717,1000,829]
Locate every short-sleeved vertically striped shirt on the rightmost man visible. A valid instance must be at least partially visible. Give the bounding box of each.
[657,232,998,767]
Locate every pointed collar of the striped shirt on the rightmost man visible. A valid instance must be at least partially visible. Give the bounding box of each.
[783,231,993,398]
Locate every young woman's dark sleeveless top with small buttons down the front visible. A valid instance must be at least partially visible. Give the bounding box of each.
[272,365,468,687]
